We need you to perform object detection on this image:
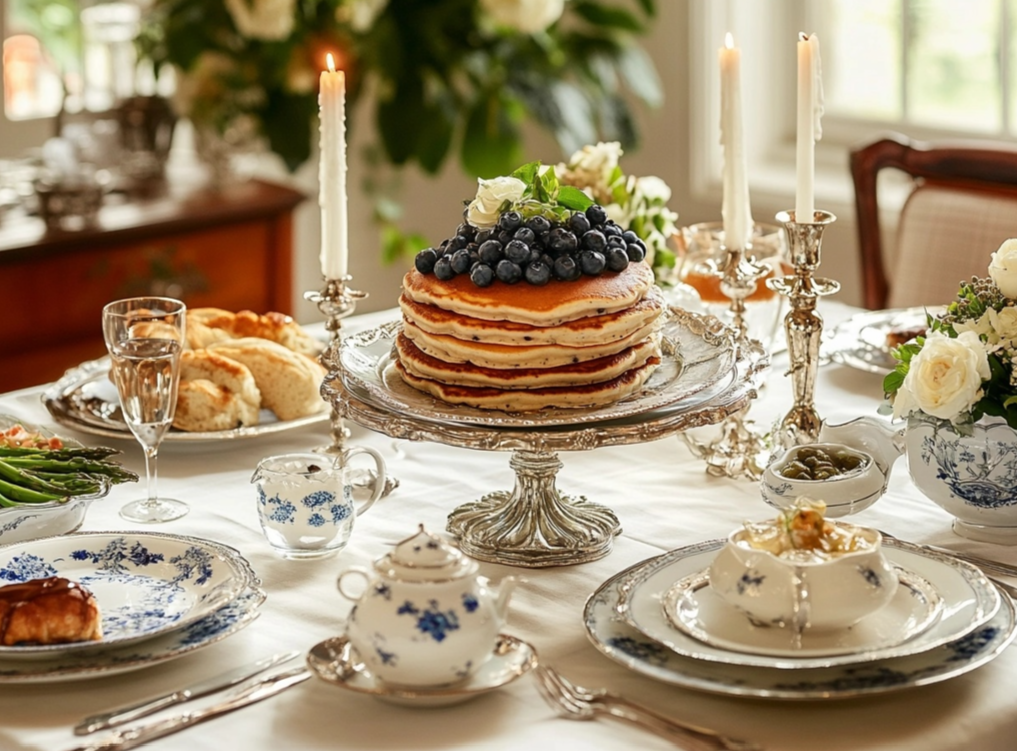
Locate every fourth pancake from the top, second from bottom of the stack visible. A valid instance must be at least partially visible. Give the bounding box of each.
[396,334,660,389]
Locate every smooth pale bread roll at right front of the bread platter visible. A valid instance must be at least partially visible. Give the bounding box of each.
[210,337,325,420]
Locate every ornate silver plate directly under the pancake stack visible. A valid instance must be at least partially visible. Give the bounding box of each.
[340,308,734,427]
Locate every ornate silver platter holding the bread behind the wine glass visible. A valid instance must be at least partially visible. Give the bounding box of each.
[43,357,328,444]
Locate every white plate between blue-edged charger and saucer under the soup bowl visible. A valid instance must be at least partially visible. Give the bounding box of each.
[618,538,1002,670]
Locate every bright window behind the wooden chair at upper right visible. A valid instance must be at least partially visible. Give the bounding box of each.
[809,0,1017,137]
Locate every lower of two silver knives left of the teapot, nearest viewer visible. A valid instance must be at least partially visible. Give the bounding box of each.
[71,668,311,751]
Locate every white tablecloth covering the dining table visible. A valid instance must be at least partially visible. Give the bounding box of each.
[0,303,1017,751]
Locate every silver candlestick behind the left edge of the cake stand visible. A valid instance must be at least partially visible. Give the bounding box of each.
[304,274,399,496]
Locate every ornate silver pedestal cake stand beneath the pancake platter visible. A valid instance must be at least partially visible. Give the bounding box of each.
[321,312,770,568]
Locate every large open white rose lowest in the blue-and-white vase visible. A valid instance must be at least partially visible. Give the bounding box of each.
[893,331,990,420]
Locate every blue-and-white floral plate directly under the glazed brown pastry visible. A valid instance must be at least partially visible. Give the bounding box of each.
[0,532,259,659]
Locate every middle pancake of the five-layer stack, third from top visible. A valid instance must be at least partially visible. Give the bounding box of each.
[403,320,657,368]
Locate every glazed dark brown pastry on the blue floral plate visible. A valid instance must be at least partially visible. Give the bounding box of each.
[0,576,103,646]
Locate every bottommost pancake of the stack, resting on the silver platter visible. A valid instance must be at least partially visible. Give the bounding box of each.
[396,357,660,412]
